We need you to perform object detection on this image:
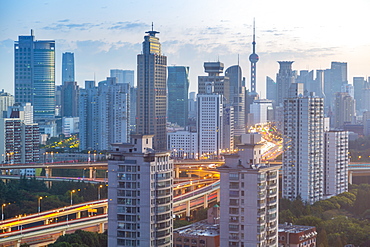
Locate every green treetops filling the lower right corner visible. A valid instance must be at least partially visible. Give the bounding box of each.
[279,184,370,247]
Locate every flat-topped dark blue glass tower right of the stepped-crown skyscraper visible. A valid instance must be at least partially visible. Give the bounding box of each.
[167,66,189,127]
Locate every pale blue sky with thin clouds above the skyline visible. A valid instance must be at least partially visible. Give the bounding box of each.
[0,0,370,97]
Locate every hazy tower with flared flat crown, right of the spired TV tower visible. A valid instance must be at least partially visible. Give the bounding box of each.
[276,61,295,105]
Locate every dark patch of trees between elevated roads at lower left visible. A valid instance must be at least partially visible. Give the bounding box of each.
[0,177,107,218]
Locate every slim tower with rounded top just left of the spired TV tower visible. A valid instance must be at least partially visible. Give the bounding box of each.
[225,65,246,135]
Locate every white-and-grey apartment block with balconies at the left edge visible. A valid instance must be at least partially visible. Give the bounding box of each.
[0,103,40,164]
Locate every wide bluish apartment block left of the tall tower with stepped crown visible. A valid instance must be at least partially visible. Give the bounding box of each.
[79,77,130,150]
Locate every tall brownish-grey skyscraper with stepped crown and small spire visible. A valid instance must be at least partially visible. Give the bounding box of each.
[136,28,167,150]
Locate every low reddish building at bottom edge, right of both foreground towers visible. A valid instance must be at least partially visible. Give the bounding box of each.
[279,223,318,247]
